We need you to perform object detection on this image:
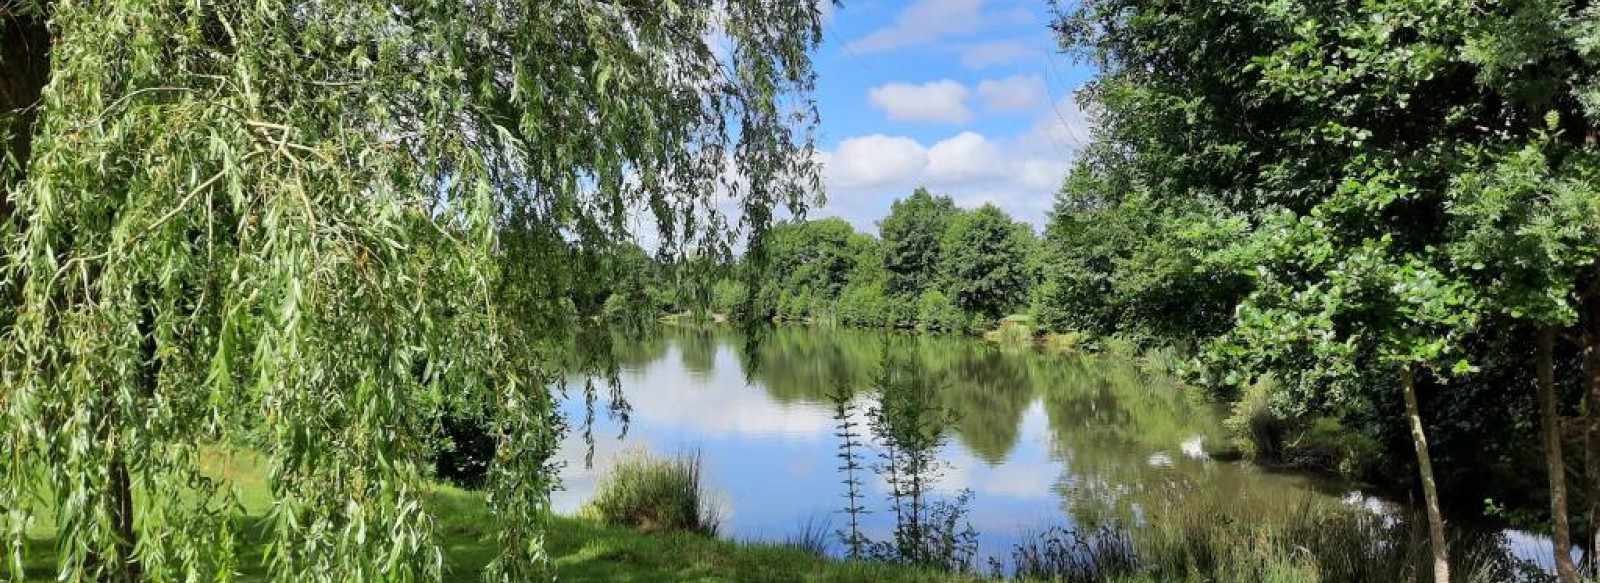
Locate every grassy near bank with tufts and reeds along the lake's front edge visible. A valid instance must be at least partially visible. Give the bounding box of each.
[9,445,1547,583]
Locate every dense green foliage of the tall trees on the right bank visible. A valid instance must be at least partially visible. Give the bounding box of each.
[1032,0,1600,525]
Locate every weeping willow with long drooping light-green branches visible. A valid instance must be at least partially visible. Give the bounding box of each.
[0,0,819,581]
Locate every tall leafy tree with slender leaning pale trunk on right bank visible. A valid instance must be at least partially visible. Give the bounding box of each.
[1046,0,1600,575]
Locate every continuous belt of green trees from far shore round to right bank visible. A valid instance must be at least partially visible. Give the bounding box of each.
[704,0,1600,581]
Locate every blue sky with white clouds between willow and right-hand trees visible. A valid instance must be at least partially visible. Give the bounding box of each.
[811,0,1093,231]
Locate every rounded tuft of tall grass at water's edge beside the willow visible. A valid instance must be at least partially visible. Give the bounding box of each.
[589,452,722,537]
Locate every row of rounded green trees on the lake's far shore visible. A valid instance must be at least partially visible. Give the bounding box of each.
[710,189,1042,332]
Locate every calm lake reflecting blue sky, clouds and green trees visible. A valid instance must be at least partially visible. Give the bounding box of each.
[552,327,1547,570]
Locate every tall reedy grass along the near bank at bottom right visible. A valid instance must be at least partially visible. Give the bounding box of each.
[992,492,1552,583]
